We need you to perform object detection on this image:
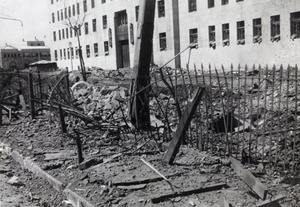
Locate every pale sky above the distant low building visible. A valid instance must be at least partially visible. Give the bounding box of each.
[0,0,49,48]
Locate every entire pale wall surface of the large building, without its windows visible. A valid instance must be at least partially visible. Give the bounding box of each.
[49,0,300,69]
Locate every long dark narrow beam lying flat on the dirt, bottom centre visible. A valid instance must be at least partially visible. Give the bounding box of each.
[151,183,227,203]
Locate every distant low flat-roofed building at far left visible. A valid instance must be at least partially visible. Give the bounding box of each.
[0,41,51,70]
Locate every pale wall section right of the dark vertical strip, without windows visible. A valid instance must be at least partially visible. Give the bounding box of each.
[179,0,300,68]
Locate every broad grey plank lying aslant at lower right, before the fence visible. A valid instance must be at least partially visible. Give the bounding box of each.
[230,157,267,200]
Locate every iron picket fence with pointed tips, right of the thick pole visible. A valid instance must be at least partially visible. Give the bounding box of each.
[154,65,300,170]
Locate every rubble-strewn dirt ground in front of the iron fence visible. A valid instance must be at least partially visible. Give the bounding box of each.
[0,68,300,207]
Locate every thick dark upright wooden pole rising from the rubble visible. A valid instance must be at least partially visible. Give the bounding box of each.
[129,0,155,130]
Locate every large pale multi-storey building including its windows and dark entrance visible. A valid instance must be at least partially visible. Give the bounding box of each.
[49,0,300,69]
